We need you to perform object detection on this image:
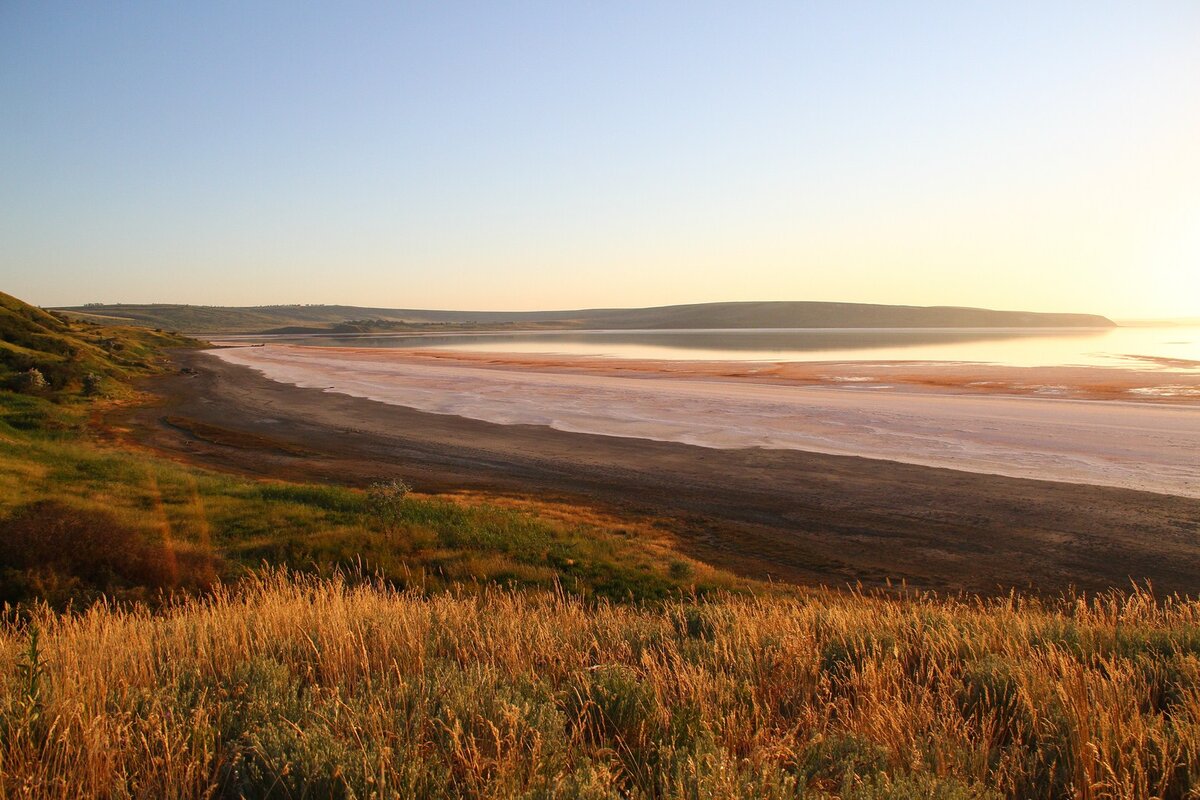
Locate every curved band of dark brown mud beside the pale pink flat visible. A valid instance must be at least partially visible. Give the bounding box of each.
[117,351,1200,594]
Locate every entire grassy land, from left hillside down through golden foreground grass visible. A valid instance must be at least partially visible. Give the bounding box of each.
[0,289,1200,800]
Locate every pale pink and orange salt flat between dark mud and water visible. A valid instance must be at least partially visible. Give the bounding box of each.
[212,345,1200,498]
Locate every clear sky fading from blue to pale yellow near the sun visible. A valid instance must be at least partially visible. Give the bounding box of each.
[0,0,1200,318]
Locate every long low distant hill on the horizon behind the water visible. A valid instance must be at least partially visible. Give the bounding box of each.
[58,301,1115,333]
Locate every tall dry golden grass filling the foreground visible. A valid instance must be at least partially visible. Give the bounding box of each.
[0,573,1200,799]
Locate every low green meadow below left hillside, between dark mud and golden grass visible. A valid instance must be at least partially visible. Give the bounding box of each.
[0,392,738,608]
